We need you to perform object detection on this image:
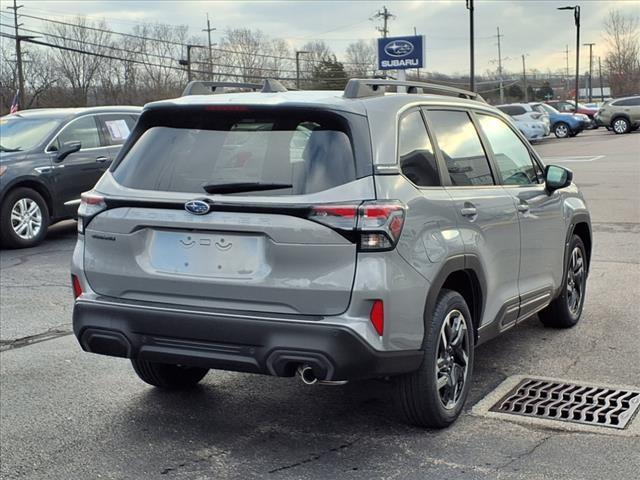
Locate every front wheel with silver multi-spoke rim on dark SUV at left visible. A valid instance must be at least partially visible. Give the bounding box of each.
[0,187,50,248]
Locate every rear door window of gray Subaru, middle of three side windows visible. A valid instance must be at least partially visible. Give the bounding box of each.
[427,111,494,186]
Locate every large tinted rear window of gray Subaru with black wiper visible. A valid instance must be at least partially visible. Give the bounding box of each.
[113,106,370,195]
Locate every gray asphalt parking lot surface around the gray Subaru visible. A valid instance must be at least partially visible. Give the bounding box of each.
[0,129,640,480]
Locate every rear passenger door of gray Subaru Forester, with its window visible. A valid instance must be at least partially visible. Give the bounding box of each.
[426,109,520,328]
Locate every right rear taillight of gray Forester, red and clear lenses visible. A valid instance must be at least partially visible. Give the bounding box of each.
[309,201,406,251]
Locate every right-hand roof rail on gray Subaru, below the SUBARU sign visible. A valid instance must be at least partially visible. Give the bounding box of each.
[344,78,486,103]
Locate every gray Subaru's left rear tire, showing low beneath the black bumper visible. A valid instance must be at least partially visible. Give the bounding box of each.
[131,358,209,390]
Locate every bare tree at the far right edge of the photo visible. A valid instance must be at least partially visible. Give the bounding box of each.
[604,10,640,96]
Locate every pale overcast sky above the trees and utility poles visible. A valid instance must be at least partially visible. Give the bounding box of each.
[1,0,640,74]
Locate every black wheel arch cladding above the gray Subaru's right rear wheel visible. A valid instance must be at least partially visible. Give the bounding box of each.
[425,255,486,342]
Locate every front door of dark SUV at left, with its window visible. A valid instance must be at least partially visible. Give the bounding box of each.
[47,115,109,213]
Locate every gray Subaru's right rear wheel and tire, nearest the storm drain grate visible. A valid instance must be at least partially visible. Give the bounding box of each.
[394,289,474,428]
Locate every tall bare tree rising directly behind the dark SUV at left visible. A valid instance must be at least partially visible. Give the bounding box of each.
[47,16,111,106]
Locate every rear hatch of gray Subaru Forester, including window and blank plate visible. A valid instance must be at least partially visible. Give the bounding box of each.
[80,105,375,315]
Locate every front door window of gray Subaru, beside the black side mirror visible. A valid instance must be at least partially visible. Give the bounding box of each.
[478,115,539,185]
